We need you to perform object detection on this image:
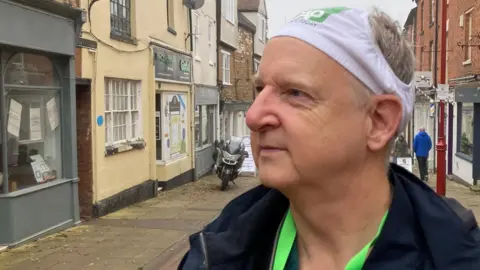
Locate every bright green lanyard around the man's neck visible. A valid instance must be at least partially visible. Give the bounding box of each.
[273,209,388,270]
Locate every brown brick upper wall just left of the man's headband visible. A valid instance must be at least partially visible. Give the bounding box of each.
[219,26,254,101]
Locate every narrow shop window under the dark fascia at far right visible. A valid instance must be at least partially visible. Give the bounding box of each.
[458,103,473,157]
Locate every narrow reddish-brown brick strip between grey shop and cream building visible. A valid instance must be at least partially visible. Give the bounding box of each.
[76,85,93,220]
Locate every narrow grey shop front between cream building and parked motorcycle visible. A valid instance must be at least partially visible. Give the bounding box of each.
[195,85,218,178]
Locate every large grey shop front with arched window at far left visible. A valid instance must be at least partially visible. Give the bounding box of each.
[0,0,82,246]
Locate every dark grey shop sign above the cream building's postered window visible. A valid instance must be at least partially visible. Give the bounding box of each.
[153,47,192,82]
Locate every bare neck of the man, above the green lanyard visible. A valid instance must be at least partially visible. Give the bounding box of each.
[289,161,391,269]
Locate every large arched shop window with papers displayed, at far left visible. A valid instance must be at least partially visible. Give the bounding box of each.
[0,53,63,191]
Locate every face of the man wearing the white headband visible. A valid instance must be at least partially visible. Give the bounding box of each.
[246,37,371,188]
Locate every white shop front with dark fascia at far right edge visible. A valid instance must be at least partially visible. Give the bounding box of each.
[452,82,480,185]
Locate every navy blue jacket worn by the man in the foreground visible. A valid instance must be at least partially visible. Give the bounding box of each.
[178,165,480,270]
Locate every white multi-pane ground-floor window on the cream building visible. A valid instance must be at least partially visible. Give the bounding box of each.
[104,77,143,146]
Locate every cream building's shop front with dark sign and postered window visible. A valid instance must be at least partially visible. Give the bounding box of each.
[153,46,195,189]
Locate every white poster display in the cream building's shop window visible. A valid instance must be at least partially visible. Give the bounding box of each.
[162,93,188,159]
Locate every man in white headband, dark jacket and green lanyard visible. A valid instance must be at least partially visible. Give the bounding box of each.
[179,8,480,270]
